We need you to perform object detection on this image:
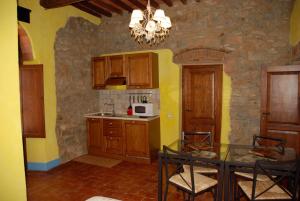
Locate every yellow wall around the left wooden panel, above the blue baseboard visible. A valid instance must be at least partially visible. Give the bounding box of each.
[19,0,100,162]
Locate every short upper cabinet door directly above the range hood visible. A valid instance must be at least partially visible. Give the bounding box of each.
[108,55,125,77]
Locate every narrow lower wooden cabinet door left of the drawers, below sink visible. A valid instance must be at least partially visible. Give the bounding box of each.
[87,118,103,154]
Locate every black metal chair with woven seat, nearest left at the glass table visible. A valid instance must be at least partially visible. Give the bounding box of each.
[163,146,218,201]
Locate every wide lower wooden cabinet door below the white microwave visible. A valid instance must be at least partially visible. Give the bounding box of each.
[124,121,149,157]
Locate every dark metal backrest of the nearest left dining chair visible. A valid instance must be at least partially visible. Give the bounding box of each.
[163,145,195,192]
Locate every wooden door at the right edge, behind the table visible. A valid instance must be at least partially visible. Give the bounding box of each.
[261,66,300,153]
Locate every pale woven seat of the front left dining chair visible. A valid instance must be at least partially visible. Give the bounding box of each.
[169,172,218,193]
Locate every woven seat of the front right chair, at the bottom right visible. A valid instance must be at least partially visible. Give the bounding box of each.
[238,180,291,200]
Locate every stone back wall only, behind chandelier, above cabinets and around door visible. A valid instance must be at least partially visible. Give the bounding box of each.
[98,0,292,143]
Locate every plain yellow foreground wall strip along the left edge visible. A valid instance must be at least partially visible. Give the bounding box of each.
[0,0,26,201]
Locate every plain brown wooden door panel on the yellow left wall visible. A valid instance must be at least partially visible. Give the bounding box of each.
[20,65,45,138]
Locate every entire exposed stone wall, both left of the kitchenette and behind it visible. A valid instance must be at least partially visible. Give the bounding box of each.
[55,0,292,161]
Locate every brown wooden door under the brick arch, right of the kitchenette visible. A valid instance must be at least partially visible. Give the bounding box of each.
[182,64,223,143]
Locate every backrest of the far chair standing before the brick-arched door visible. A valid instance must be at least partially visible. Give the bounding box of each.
[181,131,213,146]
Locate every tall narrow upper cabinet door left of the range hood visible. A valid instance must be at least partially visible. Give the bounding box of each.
[92,57,106,89]
